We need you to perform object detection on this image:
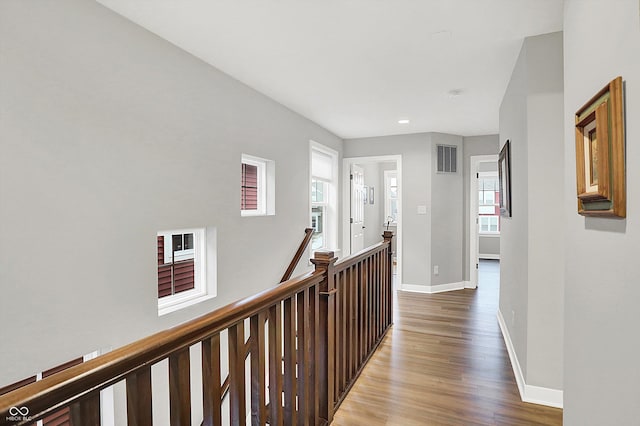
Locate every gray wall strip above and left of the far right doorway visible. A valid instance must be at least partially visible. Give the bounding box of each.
[462,135,500,281]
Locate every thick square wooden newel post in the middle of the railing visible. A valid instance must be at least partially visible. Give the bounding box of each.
[311,251,338,423]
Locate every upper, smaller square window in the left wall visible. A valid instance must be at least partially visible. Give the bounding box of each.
[240,154,275,216]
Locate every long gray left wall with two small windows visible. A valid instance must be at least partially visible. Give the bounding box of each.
[0,0,340,385]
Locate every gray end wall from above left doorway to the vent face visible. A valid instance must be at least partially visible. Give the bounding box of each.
[344,133,463,286]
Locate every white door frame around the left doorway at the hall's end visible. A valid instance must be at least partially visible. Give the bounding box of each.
[342,155,400,288]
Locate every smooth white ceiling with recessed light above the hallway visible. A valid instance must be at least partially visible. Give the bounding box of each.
[98,0,562,138]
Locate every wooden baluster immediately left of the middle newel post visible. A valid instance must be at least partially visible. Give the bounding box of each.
[297,290,311,425]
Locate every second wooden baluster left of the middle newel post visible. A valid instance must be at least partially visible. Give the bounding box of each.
[284,297,296,425]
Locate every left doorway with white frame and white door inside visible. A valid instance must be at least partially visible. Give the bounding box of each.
[342,155,402,286]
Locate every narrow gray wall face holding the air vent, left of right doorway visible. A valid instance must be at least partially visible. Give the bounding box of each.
[430,133,464,285]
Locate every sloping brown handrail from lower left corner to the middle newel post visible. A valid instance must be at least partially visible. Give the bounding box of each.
[0,271,323,418]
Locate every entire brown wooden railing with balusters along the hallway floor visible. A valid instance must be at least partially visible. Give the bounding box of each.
[0,231,393,426]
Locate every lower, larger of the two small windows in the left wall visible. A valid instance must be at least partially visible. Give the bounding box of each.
[157,228,215,315]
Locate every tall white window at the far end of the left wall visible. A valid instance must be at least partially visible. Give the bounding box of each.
[311,142,338,252]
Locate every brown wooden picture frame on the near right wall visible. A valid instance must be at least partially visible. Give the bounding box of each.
[575,77,626,218]
